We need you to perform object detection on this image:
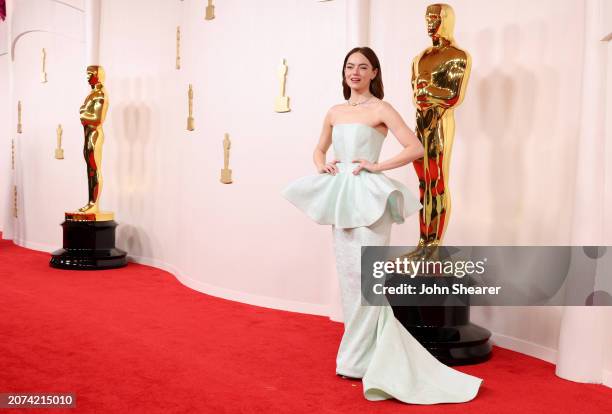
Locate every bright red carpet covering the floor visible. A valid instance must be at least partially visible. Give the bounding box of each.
[0,241,612,414]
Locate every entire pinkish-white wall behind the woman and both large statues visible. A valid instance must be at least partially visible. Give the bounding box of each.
[0,0,612,384]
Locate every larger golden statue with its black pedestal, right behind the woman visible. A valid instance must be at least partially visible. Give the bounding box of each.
[393,4,491,365]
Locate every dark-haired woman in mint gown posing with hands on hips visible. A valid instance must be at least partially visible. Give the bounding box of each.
[283,47,482,404]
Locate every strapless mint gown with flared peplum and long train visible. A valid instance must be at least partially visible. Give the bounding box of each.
[282,124,482,404]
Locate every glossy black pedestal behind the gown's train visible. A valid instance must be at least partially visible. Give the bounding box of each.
[393,306,491,365]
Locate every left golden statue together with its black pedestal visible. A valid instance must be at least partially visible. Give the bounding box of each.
[51,66,127,269]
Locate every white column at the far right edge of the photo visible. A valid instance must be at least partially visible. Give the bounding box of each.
[556,0,609,383]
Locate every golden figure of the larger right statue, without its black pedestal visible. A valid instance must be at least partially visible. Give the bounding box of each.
[409,4,471,258]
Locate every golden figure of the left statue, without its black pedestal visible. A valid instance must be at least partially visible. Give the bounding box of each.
[66,66,113,221]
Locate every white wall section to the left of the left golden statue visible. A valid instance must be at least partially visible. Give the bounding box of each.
[4,0,87,246]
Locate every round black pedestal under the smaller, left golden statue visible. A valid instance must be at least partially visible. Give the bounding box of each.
[49,220,127,270]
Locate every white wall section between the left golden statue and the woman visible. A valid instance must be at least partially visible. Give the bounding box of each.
[101,1,352,313]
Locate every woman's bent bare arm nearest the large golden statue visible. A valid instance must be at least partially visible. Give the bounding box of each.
[353,102,424,174]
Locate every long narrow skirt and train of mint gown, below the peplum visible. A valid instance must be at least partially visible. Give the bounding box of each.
[332,209,482,404]
